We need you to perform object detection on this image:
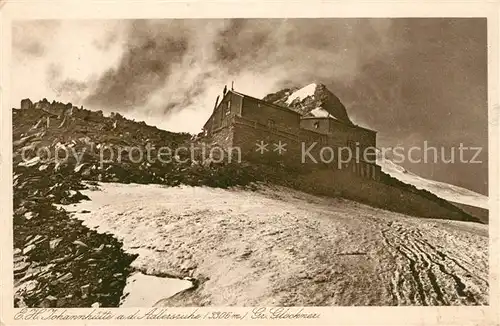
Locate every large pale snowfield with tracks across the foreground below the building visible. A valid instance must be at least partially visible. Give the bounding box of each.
[60,183,488,309]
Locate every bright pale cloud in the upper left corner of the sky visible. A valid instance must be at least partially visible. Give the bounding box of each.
[10,20,126,106]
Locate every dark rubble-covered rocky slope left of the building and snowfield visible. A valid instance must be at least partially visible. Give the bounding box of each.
[13,100,266,307]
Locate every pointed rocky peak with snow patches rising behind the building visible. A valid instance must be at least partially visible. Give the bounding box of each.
[263,83,352,124]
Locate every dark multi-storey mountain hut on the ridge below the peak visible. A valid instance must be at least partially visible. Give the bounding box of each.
[203,84,380,180]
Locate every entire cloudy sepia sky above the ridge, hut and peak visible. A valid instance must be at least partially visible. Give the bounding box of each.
[11,18,488,193]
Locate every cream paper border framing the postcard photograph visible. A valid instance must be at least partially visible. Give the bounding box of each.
[0,0,500,325]
